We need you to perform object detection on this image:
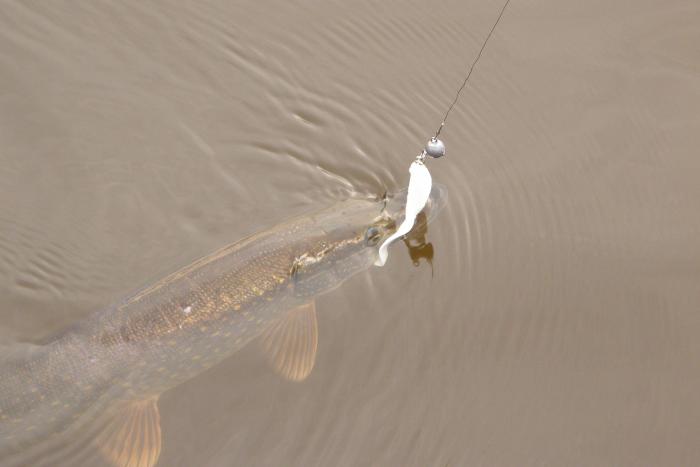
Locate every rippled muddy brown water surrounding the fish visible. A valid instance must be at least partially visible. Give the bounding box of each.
[0,0,700,467]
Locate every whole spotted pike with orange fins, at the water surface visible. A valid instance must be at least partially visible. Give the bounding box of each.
[0,185,447,467]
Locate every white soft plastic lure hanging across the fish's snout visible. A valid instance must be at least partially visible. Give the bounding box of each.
[374,159,433,266]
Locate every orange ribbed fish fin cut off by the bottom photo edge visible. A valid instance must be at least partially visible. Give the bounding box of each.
[96,397,161,467]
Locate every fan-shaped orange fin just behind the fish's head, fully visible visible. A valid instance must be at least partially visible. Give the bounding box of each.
[261,302,318,381]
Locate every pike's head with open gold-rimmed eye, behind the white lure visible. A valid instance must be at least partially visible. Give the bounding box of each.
[290,184,447,297]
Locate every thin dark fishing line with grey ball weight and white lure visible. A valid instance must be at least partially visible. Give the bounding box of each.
[374,0,510,266]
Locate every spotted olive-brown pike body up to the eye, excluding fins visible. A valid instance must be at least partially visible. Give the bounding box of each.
[0,194,404,458]
